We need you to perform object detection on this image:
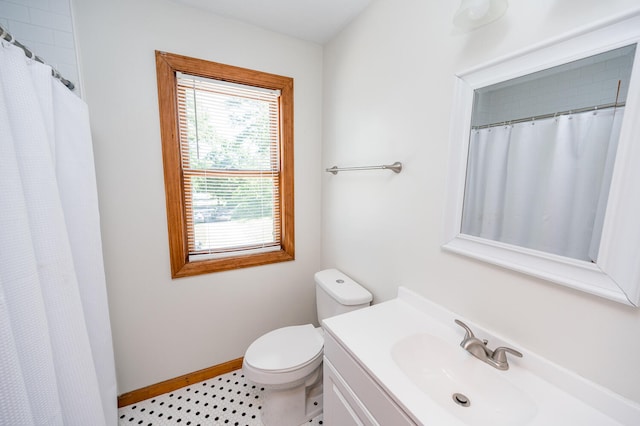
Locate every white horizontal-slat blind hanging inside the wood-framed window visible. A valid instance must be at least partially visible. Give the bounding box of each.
[177,73,281,260]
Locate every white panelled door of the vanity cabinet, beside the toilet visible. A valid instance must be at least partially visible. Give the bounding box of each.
[322,358,378,426]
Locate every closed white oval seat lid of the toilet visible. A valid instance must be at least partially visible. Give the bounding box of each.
[244,324,324,373]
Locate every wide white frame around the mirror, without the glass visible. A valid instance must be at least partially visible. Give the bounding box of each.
[442,10,640,306]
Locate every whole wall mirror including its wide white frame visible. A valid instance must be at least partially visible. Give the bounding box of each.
[443,12,640,306]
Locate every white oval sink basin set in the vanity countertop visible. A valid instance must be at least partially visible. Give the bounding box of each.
[391,333,537,426]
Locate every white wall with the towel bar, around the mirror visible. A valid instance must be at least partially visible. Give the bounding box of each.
[322,0,640,402]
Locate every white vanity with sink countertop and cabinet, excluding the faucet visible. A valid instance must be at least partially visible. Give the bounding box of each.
[322,287,640,426]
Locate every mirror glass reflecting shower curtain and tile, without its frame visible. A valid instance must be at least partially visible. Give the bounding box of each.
[461,45,636,263]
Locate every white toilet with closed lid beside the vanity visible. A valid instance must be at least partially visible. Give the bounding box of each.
[242,269,372,426]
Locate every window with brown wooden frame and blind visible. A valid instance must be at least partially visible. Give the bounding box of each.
[156,51,294,278]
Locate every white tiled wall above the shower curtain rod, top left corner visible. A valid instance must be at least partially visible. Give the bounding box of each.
[0,0,78,92]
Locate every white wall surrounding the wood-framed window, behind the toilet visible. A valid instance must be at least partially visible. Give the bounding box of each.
[73,0,322,393]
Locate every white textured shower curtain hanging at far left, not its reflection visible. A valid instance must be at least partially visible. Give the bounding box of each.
[0,42,117,426]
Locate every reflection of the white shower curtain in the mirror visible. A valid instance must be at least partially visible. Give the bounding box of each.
[462,108,623,261]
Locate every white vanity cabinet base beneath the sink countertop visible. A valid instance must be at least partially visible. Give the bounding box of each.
[323,332,417,426]
